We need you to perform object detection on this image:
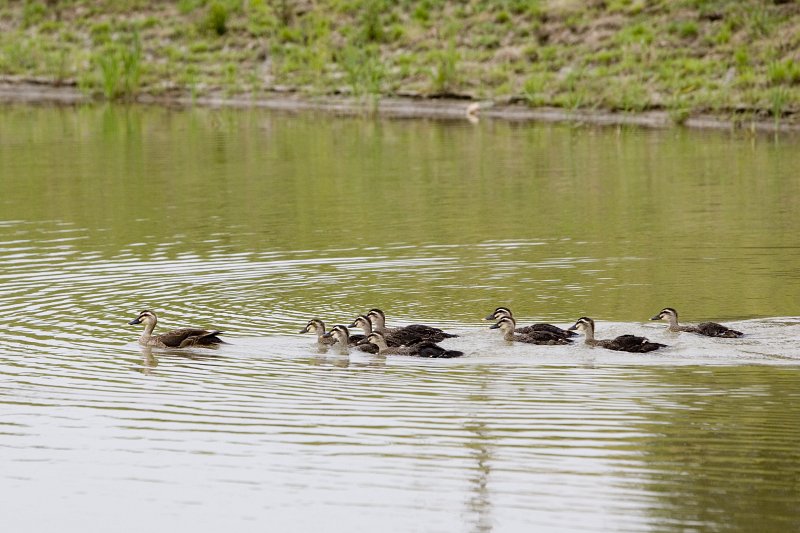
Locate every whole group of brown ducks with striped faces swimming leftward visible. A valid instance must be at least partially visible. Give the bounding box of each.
[129,307,743,359]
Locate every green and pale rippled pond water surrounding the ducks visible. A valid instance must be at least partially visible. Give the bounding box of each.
[0,107,800,532]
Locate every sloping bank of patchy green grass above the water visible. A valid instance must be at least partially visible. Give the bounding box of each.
[0,0,800,123]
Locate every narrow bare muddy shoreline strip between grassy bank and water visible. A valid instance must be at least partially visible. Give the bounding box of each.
[0,77,800,134]
